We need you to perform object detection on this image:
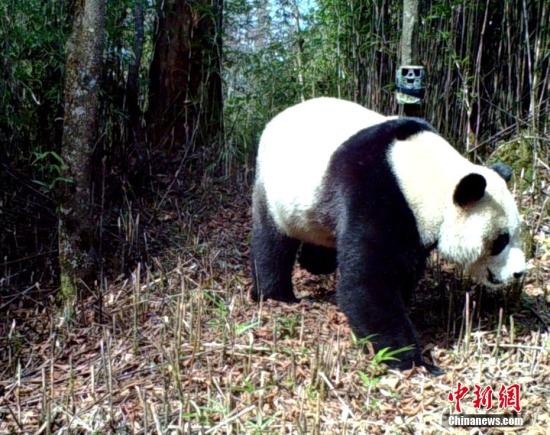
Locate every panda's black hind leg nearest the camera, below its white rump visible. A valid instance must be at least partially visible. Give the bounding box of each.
[250,187,300,302]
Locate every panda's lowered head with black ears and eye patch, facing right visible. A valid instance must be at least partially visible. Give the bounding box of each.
[438,165,525,287]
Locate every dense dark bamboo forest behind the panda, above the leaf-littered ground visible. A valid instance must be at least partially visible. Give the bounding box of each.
[0,0,550,288]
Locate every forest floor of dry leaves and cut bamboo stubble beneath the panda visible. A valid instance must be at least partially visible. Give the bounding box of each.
[0,176,550,434]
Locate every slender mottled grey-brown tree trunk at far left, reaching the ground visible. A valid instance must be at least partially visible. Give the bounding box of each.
[59,0,105,316]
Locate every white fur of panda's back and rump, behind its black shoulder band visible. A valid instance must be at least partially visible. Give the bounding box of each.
[256,97,388,246]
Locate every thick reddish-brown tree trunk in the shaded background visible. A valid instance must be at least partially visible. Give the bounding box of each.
[148,0,223,162]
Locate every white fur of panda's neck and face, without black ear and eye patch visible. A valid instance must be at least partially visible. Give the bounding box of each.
[389,132,525,286]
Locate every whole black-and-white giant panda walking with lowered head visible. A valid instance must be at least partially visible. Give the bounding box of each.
[251,98,525,373]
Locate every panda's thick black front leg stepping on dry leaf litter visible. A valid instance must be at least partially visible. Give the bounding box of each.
[337,228,439,374]
